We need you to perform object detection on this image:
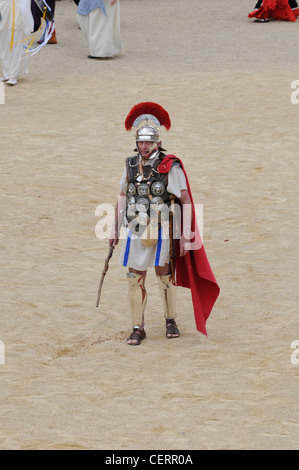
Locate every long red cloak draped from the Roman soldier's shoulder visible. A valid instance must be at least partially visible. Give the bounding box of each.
[157,155,220,336]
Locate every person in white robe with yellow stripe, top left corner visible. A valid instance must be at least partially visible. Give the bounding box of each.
[0,0,33,85]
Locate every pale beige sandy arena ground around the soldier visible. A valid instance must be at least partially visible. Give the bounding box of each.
[0,0,299,450]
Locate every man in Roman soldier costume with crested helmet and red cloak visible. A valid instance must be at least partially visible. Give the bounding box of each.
[109,102,219,345]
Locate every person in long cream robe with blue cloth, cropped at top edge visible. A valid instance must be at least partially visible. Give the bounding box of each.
[77,0,121,59]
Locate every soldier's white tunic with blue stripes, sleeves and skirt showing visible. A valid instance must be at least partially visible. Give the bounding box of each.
[119,165,187,271]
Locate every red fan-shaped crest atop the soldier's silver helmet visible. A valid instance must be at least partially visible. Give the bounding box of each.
[125,101,171,131]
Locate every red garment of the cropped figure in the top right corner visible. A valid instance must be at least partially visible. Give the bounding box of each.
[248,0,299,21]
